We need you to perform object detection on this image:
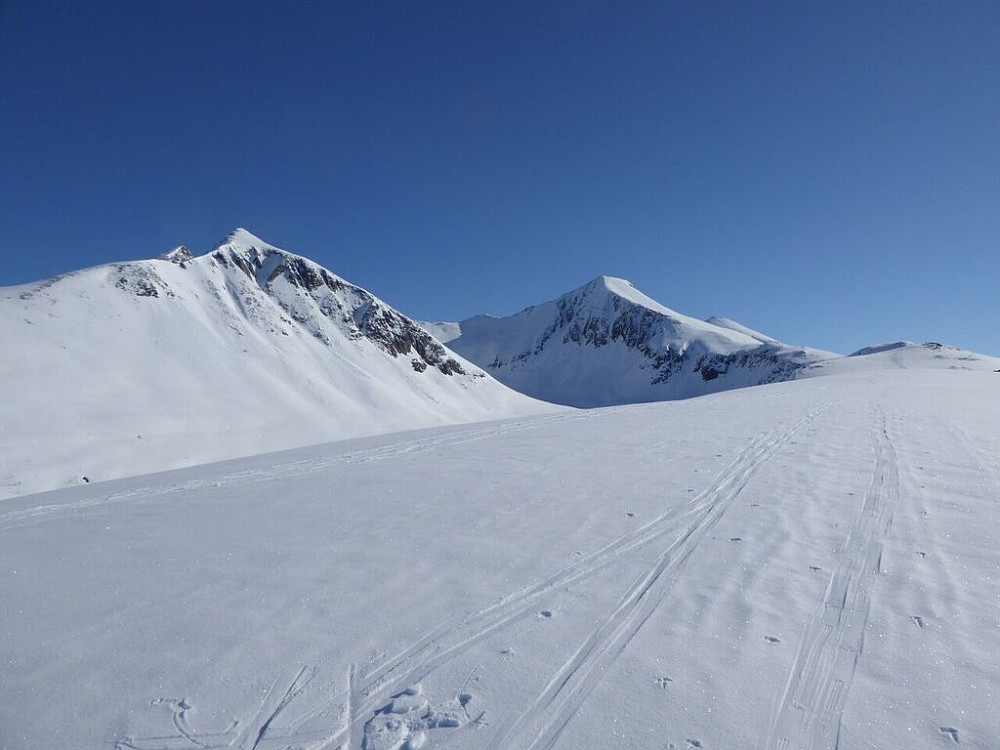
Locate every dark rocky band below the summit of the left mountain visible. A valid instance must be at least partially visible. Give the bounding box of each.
[212,248,465,375]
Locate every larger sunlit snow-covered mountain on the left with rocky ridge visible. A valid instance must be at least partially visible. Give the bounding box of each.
[0,229,553,497]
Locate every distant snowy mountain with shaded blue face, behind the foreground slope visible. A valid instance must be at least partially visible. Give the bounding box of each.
[424,276,835,407]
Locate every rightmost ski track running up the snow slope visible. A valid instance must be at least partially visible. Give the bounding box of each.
[763,411,899,750]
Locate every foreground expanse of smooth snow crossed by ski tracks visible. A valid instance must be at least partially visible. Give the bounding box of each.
[0,346,1000,750]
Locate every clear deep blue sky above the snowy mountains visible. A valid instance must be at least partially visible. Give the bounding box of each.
[0,0,1000,354]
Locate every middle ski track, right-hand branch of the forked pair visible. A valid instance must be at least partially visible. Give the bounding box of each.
[488,406,828,750]
